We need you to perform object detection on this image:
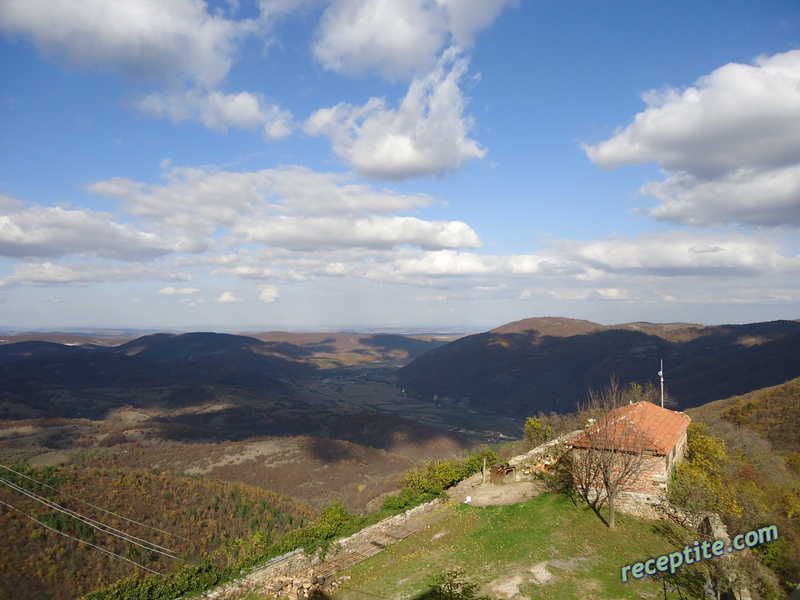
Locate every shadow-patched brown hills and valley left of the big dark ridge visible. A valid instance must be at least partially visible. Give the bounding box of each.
[0,332,476,510]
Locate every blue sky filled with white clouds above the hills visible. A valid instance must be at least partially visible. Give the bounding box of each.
[0,0,800,330]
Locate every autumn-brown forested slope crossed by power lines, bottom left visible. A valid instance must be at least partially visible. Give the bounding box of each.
[0,466,314,600]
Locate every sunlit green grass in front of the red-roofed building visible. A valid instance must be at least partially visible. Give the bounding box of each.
[331,493,689,600]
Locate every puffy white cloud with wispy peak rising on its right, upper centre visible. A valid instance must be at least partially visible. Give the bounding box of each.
[305,46,486,180]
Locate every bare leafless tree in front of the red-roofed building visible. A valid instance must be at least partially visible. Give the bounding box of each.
[572,377,648,529]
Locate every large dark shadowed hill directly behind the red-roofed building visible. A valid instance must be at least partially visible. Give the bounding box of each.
[398,318,800,417]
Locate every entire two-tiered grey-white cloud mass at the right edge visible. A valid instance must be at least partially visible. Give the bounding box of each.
[585,50,800,227]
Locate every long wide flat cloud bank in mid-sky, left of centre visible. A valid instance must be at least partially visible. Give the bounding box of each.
[87,167,480,250]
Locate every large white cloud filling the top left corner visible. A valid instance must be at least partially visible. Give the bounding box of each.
[0,0,244,87]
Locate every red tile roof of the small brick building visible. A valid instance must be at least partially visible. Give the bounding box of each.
[572,402,691,455]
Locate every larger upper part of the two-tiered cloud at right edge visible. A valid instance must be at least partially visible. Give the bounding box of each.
[586,50,800,175]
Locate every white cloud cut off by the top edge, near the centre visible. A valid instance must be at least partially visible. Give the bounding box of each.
[314,0,515,80]
